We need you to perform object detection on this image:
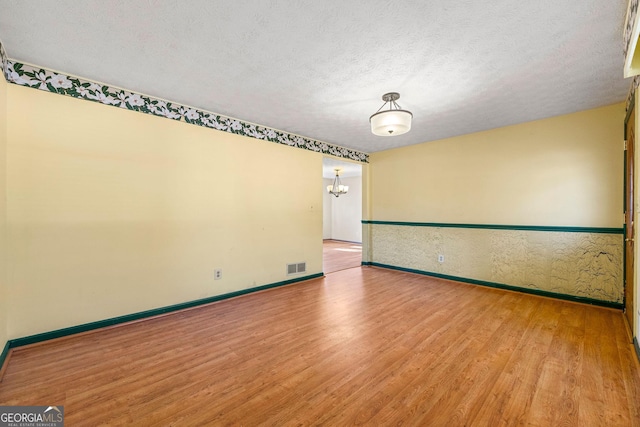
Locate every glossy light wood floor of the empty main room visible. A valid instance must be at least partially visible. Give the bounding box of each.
[0,267,640,426]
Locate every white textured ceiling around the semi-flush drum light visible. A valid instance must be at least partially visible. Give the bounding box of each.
[0,0,630,153]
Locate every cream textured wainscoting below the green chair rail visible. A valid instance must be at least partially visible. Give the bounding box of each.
[370,224,624,303]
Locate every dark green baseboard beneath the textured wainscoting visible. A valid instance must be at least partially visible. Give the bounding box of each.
[362,262,624,310]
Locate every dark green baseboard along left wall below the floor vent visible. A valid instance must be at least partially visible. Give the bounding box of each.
[0,273,324,367]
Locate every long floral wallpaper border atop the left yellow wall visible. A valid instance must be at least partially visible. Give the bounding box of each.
[0,43,369,163]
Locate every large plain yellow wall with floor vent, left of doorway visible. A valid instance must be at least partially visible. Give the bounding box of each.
[7,85,322,338]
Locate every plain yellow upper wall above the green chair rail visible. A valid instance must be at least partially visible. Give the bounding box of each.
[370,103,624,227]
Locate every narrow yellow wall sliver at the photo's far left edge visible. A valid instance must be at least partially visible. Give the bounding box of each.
[0,68,8,352]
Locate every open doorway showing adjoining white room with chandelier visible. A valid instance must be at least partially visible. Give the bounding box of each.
[322,157,362,274]
